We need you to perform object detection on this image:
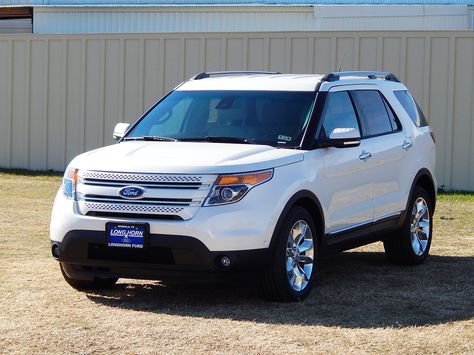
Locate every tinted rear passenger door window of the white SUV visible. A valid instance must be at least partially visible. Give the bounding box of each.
[351,90,396,137]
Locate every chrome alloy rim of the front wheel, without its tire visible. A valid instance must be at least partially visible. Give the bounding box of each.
[286,220,314,292]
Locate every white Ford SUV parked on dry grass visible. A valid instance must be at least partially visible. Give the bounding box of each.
[51,72,436,301]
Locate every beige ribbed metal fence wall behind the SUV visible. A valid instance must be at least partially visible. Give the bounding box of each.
[0,31,474,190]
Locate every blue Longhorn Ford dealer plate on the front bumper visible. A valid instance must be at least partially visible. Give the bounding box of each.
[105,222,149,249]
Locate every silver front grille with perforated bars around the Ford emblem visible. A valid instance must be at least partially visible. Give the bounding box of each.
[77,171,217,220]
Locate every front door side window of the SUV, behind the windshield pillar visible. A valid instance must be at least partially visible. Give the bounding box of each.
[323,91,360,137]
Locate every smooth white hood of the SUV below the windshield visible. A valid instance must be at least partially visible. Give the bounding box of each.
[71,141,303,174]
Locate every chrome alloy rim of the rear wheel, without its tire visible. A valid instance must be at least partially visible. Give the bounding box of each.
[410,197,431,256]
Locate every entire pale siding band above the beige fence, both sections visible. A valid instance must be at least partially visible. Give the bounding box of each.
[34,5,470,34]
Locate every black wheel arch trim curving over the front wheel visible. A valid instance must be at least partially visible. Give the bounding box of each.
[270,190,324,250]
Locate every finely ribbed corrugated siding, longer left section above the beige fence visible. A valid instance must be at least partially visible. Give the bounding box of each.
[34,8,315,33]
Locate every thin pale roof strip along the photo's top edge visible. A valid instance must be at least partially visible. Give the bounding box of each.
[0,0,474,7]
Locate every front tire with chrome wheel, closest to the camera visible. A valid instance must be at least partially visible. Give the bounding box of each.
[263,206,318,302]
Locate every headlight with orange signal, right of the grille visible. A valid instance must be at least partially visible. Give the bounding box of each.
[204,170,273,206]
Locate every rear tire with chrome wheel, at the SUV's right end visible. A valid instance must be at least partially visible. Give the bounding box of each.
[384,186,433,265]
